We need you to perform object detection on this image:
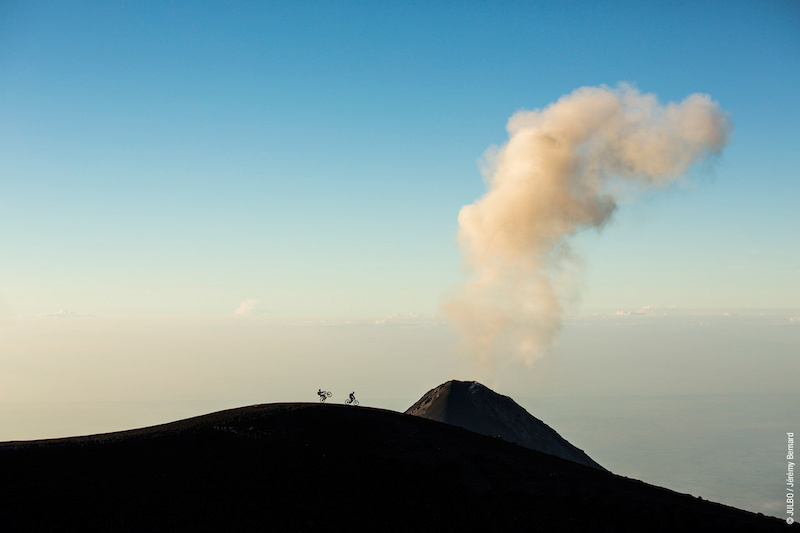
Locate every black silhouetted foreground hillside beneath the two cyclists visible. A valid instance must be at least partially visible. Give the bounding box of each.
[0,404,800,532]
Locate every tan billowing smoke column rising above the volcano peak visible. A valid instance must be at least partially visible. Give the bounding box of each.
[445,85,731,371]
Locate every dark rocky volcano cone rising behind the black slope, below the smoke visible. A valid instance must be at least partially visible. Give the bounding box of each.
[406,380,605,470]
